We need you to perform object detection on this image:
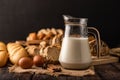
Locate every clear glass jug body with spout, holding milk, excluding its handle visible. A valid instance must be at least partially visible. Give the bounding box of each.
[59,15,92,69]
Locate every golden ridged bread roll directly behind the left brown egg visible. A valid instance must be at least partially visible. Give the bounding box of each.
[7,43,28,64]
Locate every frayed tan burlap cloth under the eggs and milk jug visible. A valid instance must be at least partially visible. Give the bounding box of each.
[8,64,95,77]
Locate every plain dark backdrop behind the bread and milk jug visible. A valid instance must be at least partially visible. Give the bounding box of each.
[0,0,120,47]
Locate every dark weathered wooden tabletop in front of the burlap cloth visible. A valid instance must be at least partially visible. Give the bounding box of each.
[0,63,120,80]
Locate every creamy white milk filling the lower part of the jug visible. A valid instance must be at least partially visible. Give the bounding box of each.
[59,37,91,69]
